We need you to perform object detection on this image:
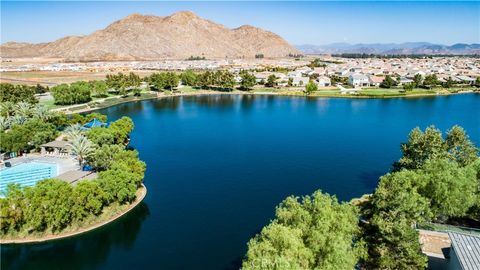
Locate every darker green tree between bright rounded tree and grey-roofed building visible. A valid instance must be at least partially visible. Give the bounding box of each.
[362,170,432,270]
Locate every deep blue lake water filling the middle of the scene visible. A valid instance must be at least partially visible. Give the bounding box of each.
[1,94,480,269]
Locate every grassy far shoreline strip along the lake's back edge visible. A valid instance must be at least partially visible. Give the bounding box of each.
[44,87,480,114]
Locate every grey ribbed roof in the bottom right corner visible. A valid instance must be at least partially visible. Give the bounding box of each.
[447,232,480,270]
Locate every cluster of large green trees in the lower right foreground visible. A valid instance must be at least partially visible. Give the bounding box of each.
[242,126,480,269]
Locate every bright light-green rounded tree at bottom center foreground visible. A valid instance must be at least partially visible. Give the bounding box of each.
[242,191,364,269]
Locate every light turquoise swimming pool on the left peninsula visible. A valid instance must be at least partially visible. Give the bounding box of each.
[0,161,58,193]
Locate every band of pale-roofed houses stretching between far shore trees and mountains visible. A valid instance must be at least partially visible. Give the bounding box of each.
[0,55,480,89]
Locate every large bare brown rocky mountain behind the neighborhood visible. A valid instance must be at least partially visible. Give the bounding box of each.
[0,11,300,61]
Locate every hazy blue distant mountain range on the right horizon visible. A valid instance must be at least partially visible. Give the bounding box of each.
[297,42,480,55]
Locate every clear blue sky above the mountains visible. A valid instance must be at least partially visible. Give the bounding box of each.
[1,0,480,45]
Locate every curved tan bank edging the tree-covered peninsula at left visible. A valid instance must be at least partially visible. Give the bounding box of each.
[0,184,147,245]
